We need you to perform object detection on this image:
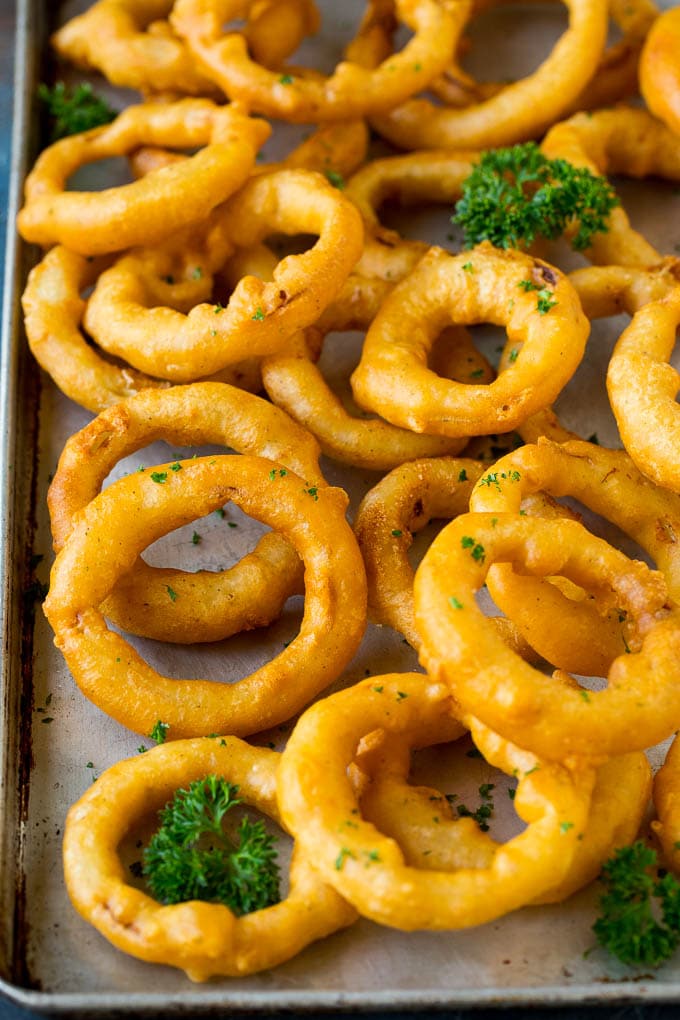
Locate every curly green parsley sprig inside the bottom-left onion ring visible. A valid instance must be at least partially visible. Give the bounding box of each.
[143,775,280,916]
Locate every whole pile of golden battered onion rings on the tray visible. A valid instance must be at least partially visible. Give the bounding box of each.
[17,0,680,980]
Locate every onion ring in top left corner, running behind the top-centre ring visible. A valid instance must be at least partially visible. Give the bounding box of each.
[52,0,318,96]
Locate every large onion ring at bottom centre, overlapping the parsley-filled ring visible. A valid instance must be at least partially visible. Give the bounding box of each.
[277,673,593,931]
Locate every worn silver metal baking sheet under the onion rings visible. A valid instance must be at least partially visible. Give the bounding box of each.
[0,0,680,1016]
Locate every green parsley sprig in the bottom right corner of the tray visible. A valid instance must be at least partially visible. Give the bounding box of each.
[592,840,680,967]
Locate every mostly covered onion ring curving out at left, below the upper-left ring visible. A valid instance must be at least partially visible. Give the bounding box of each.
[21,245,262,414]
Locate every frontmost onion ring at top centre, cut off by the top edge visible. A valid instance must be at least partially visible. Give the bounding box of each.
[170,0,465,123]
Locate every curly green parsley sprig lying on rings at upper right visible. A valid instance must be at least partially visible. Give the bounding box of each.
[452,142,619,251]
